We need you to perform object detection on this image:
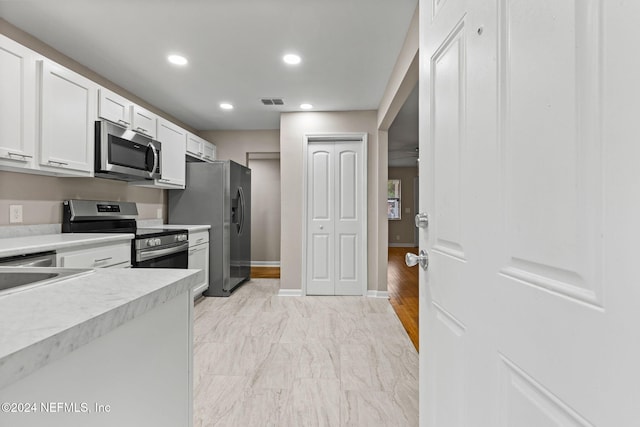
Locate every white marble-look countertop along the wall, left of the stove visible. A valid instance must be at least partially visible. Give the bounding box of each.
[0,233,135,258]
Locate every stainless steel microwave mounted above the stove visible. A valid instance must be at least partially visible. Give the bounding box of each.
[95,120,162,181]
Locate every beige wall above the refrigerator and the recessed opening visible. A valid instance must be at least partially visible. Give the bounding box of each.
[200,129,280,166]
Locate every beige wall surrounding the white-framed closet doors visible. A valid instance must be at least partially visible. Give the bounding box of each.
[280,111,386,290]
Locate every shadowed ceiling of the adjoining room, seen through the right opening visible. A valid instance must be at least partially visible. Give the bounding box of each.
[389,84,418,167]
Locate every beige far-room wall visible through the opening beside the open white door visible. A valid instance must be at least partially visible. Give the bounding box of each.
[388,168,418,246]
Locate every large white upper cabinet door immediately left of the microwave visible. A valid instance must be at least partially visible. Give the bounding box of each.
[38,60,97,176]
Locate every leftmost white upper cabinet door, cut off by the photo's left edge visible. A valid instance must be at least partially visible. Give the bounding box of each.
[0,36,36,169]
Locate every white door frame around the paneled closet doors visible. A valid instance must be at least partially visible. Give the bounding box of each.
[301,132,369,296]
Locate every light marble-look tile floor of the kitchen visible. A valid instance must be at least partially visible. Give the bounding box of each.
[194,279,418,427]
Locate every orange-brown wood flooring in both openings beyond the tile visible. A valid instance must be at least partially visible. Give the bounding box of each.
[251,248,420,351]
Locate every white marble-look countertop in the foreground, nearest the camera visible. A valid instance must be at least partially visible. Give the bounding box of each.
[0,268,201,388]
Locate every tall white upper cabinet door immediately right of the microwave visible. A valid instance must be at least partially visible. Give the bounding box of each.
[158,119,187,188]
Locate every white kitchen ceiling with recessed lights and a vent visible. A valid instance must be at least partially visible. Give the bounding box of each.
[0,0,417,130]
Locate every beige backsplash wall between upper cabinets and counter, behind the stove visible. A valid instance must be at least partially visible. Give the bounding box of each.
[0,171,165,225]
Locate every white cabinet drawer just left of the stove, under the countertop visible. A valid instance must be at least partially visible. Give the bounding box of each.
[58,242,131,268]
